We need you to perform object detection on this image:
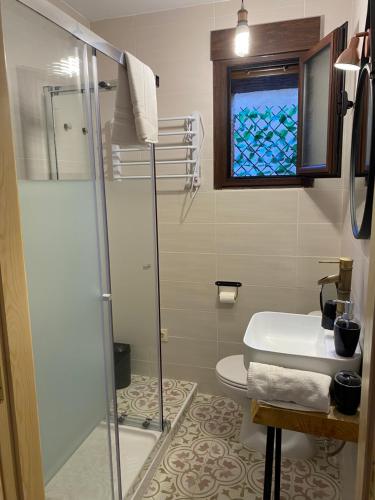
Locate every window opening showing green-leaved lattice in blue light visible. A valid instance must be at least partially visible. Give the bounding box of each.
[231,74,298,177]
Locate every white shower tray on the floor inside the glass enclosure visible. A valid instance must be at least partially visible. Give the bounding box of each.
[46,423,161,500]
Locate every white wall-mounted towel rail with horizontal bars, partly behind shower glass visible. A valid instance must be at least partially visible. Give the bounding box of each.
[112,111,204,191]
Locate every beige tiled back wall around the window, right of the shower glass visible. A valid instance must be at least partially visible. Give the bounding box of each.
[92,0,352,392]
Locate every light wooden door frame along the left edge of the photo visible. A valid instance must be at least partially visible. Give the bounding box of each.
[0,4,45,500]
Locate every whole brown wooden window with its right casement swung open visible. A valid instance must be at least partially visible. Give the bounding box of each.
[211,18,346,189]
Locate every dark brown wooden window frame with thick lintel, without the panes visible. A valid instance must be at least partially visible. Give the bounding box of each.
[211,17,342,189]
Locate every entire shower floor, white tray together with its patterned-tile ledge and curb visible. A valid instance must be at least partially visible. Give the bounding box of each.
[46,375,197,500]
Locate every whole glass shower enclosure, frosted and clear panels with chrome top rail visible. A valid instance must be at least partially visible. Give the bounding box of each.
[0,0,163,500]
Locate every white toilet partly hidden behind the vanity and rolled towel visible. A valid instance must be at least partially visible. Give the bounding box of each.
[216,355,316,459]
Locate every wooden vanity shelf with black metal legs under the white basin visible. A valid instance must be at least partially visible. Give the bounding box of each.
[251,400,359,500]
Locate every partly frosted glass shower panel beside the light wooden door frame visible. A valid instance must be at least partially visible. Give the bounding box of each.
[2,0,121,500]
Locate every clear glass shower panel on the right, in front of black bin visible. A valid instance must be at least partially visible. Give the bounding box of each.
[97,54,164,495]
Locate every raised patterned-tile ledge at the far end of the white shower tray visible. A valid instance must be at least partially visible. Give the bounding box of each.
[117,375,194,422]
